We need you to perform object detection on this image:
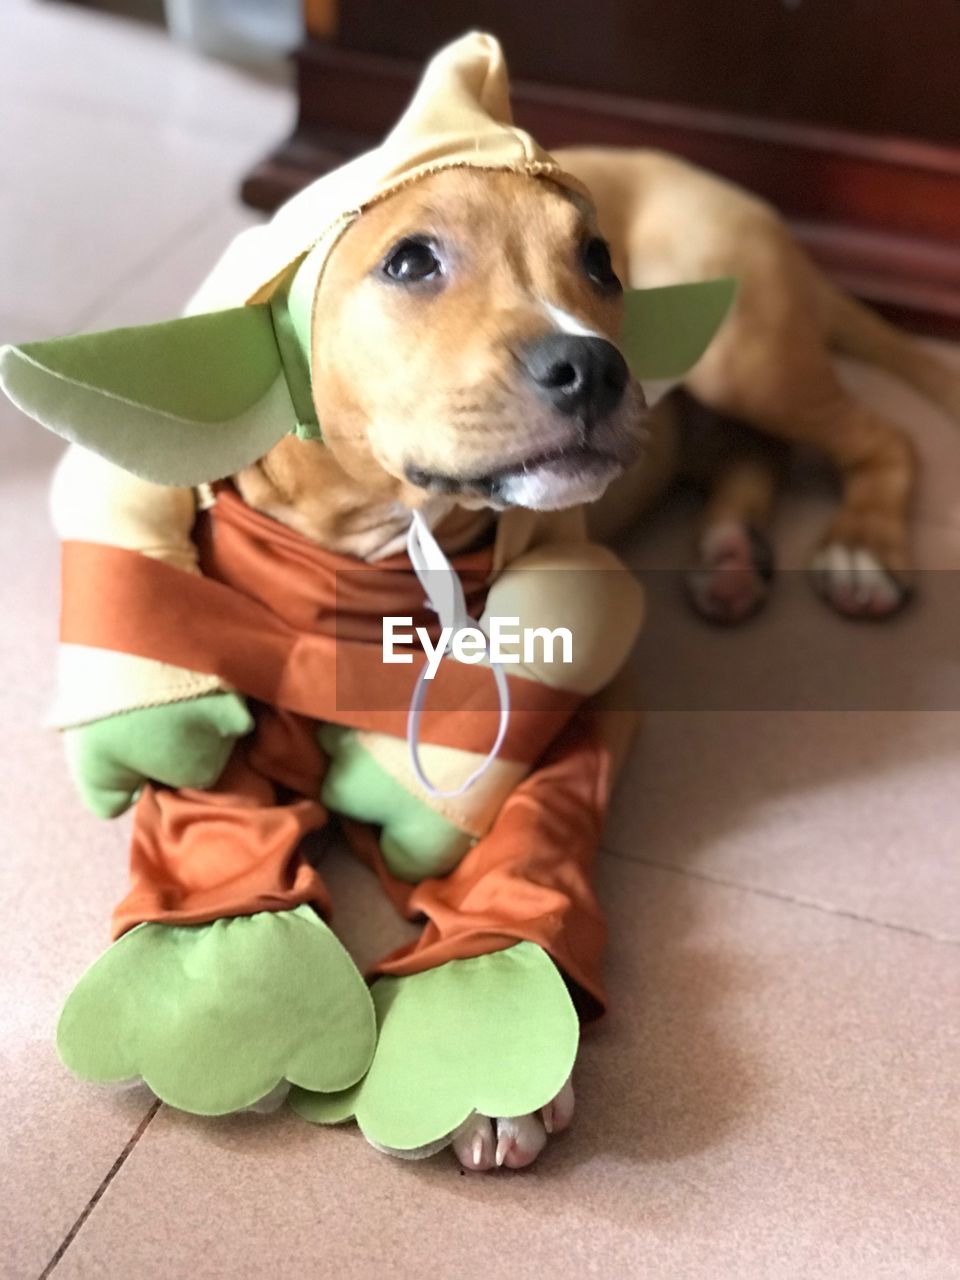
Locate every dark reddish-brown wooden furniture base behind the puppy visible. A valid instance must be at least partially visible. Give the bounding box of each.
[242,41,960,338]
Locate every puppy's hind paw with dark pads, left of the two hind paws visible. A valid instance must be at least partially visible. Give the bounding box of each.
[686,521,773,625]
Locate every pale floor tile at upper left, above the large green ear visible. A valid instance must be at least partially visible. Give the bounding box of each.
[0,96,273,340]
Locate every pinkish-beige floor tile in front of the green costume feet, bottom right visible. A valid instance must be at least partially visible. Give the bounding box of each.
[45,859,960,1280]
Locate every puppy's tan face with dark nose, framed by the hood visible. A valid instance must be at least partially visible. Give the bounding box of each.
[278,169,645,509]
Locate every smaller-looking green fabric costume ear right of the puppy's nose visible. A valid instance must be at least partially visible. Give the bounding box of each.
[622,279,737,381]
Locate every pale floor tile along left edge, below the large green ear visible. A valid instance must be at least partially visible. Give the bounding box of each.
[0,401,156,1280]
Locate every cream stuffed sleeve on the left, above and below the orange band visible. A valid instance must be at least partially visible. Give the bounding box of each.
[47,445,228,728]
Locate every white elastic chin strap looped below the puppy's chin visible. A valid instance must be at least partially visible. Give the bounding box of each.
[407,511,509,799]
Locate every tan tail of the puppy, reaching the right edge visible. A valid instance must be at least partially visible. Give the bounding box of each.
[819,278,960,422]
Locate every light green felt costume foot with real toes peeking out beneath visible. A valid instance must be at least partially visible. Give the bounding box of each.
[288,942,579,1167]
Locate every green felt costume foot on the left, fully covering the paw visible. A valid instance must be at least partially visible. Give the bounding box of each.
[58,906,376,1115]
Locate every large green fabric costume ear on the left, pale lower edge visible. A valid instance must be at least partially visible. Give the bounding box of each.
[0,303,304,485]
